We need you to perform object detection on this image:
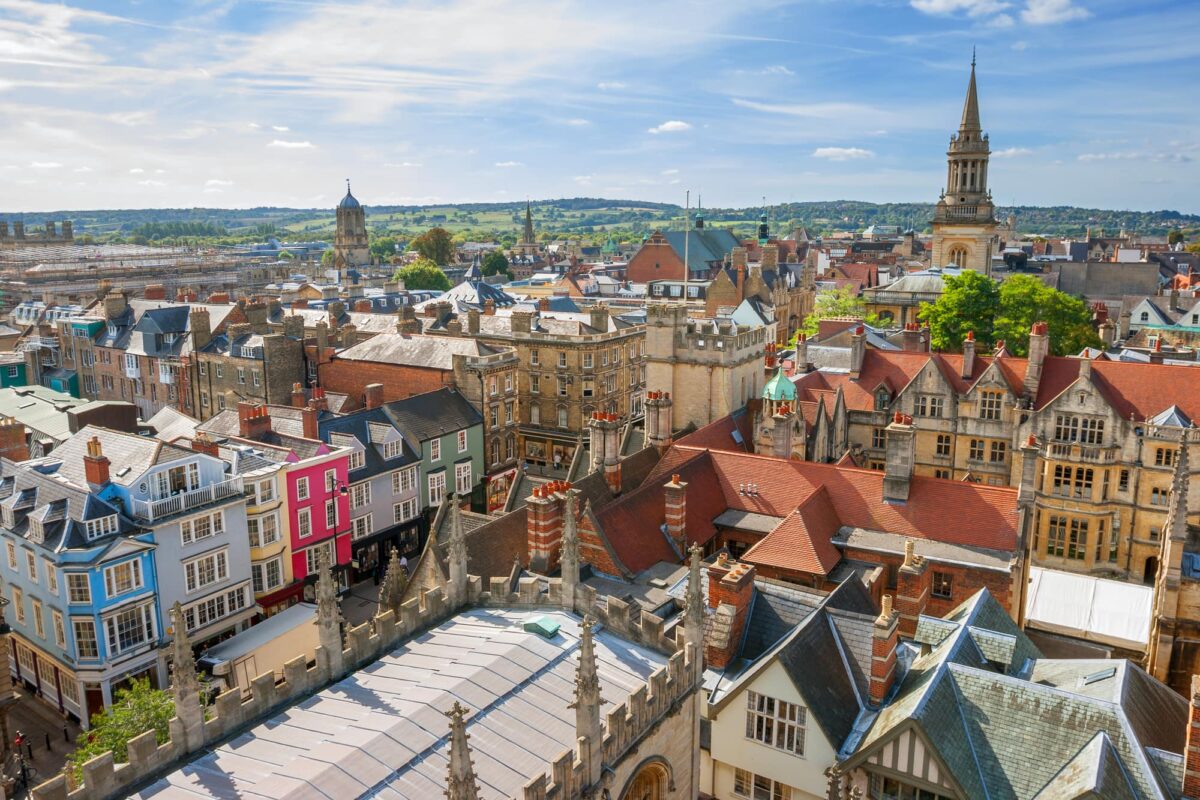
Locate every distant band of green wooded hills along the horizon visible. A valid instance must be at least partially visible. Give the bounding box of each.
[0,198,1200,243]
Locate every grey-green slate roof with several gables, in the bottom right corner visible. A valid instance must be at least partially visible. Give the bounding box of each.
[847,590,1187,800]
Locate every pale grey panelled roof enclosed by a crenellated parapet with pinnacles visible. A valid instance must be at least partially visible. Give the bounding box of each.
[133,609,666,800]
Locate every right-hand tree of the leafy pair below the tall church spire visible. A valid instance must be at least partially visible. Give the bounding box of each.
[992,275,1100,355]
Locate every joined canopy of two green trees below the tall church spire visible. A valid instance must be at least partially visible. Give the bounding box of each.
[920,270,1100,355]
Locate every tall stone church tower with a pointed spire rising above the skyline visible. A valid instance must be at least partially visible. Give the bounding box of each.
[932,56,996,275]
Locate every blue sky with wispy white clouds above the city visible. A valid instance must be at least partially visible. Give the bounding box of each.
[0,0,1200,212]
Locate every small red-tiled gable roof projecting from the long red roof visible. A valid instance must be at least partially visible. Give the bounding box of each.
[742,486,841,576]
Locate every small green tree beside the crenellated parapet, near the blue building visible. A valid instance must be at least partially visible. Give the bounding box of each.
[67,678,175,778]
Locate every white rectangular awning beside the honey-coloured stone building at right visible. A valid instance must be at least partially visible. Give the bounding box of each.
[1025,566,1154,650]
